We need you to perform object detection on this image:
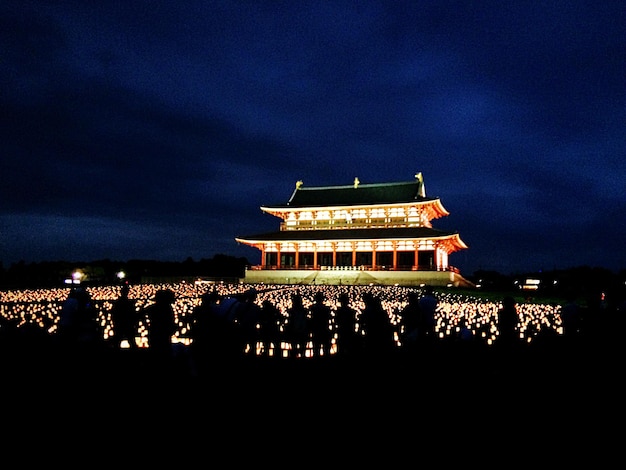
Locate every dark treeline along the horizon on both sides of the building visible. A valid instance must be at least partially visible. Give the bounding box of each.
[0,254,626,298]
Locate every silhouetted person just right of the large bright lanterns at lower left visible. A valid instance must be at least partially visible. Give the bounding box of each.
[144,289,176,369]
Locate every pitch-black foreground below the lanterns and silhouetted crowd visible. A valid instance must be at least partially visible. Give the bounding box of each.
[1,332,626,468]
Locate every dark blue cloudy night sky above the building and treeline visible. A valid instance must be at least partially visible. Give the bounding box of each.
[0,0,626,274]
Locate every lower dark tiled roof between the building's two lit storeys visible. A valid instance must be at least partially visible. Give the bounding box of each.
[237,227,456,242]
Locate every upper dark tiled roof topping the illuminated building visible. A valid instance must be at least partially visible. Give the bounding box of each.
[271,180,437,208]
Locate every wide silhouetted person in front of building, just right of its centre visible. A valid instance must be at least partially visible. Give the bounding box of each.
[359,293,396,358]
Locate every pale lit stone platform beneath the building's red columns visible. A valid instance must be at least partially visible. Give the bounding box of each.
[243,269,475,288]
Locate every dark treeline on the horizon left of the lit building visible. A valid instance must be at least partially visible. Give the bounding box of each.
[0,254,250,289]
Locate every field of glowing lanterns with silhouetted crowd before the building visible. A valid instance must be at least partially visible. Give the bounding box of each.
[0,284,623,386]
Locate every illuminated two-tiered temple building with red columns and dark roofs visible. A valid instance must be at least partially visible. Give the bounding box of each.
[235,173,472,287]
